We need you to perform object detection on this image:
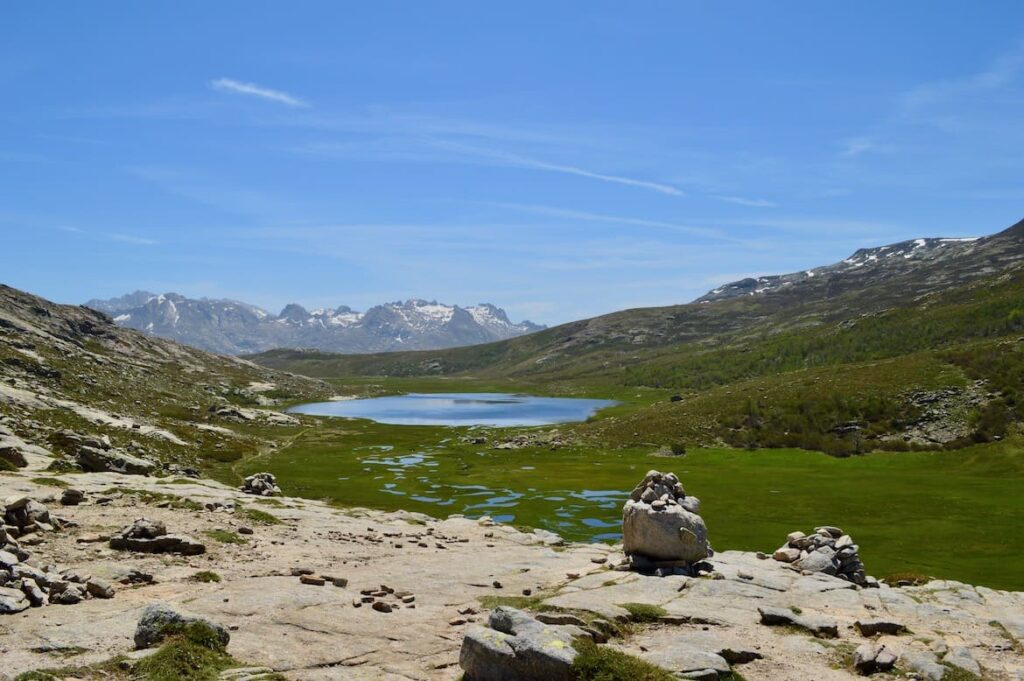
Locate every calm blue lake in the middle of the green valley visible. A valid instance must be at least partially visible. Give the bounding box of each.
[289,392,615,427]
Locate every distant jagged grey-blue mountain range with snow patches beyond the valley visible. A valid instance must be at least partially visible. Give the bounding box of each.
[85,291,544,354]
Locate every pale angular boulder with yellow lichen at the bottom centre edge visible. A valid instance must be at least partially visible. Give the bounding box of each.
[459,606,588,681]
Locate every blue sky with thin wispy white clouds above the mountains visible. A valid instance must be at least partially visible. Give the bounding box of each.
[0,0,1024,324]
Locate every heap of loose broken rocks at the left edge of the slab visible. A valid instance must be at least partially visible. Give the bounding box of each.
[0,497,114,614]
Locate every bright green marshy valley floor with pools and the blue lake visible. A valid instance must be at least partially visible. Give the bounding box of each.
[232,379,1024,590]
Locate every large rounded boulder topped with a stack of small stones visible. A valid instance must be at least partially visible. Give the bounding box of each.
[623,470,714,576]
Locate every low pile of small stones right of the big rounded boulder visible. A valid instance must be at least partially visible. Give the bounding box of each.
[772,525,879,587]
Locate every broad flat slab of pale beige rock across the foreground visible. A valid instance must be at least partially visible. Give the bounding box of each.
[0,472,1024,681]
